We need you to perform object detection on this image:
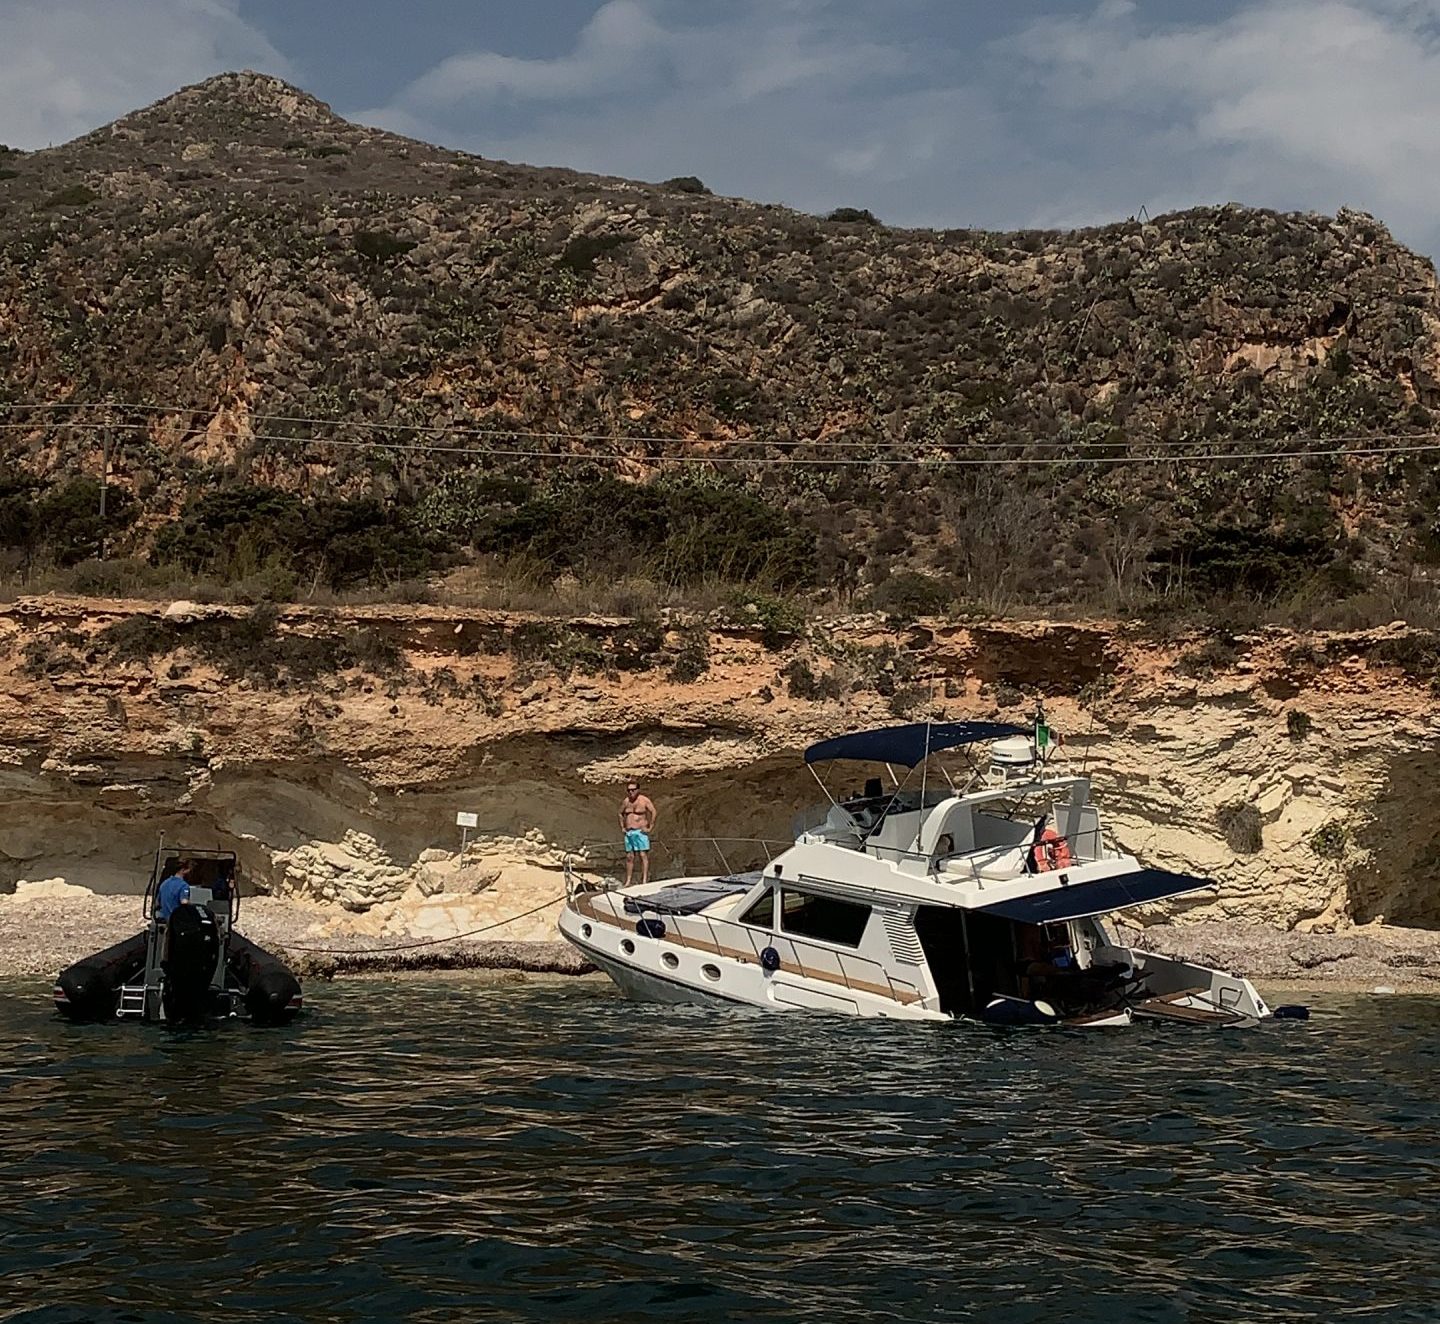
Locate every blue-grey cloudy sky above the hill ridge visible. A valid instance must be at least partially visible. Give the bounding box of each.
[0,0,1440,254]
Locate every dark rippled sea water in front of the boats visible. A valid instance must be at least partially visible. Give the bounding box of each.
[0,978,1440,1321]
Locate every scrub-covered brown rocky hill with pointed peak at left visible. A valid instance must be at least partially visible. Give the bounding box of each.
[0,73,1440,619]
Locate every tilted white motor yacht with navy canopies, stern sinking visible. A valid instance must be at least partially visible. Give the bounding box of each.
[560,715,1272,1026]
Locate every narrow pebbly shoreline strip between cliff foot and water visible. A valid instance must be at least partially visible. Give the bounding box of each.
[0,887,1440,993]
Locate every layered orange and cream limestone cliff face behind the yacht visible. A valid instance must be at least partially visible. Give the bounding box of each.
[0,599,1440,929]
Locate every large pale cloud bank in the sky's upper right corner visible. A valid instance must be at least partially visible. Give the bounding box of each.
[1014,0,1440,249]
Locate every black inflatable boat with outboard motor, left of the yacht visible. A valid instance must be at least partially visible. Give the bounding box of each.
[55,844,302,1024]
